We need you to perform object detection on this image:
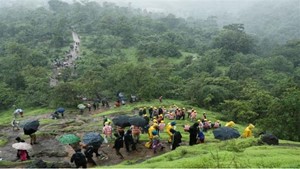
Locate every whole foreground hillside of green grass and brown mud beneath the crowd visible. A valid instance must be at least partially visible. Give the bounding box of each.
[0,100,300,168]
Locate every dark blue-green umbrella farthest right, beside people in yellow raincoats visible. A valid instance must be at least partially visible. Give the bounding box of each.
[213,127,240,140]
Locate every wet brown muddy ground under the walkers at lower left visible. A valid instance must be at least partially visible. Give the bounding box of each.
[0,109,170,168]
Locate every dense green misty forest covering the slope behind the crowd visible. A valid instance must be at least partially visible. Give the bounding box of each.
[0,0,300,141]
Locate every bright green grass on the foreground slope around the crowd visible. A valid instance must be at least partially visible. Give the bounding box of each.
[0,100,300,168]
